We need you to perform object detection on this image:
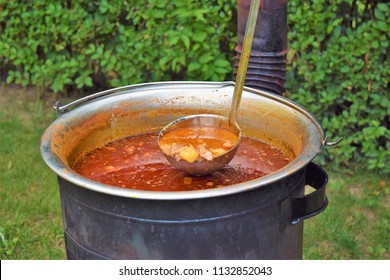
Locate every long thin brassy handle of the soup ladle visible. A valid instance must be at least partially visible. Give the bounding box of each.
[229,0,260,125]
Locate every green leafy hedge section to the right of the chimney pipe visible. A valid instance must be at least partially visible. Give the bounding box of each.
[287,0,390,173]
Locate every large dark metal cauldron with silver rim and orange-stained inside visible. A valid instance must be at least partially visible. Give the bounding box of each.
[41,82,327,259]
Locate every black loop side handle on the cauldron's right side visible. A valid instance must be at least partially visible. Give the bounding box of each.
[281,163,328,230]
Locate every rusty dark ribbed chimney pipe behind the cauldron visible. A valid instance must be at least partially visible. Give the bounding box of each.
[235,0,288,95]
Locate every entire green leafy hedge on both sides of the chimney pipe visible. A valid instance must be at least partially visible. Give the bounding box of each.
[0,0,390,173]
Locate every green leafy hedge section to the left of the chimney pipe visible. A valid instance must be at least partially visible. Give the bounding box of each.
[0,0,236,92]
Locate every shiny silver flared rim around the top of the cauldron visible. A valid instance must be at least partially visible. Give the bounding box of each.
[40,81,326,200]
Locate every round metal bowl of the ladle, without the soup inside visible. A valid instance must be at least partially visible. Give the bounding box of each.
[158,114,242,176]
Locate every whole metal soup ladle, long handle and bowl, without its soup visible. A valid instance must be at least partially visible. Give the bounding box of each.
[158,0,260,176]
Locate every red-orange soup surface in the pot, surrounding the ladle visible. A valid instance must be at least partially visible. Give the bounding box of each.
[74,132,290,191]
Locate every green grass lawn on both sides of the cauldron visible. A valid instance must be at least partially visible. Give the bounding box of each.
[0,85,390,259]
